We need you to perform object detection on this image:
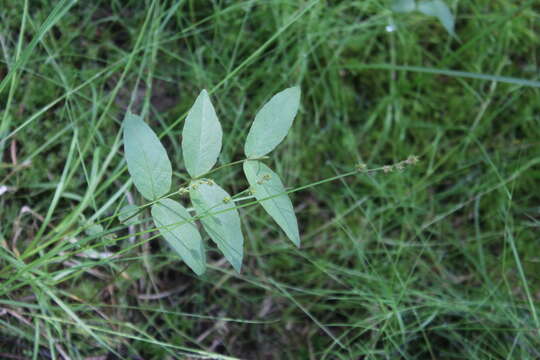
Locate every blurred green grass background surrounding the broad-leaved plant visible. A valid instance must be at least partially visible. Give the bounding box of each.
[0,0,540,359]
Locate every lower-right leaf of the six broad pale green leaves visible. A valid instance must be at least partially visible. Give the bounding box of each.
[244,161,300,247]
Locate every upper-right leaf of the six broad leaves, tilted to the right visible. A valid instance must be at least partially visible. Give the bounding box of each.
[244,86,300,158]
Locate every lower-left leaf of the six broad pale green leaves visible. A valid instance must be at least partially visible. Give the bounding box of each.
[152,199,206,275]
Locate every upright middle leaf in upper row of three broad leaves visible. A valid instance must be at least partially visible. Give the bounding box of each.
[182,90,223,178]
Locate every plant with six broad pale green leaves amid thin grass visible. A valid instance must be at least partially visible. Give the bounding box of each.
[119,87,300,275]
